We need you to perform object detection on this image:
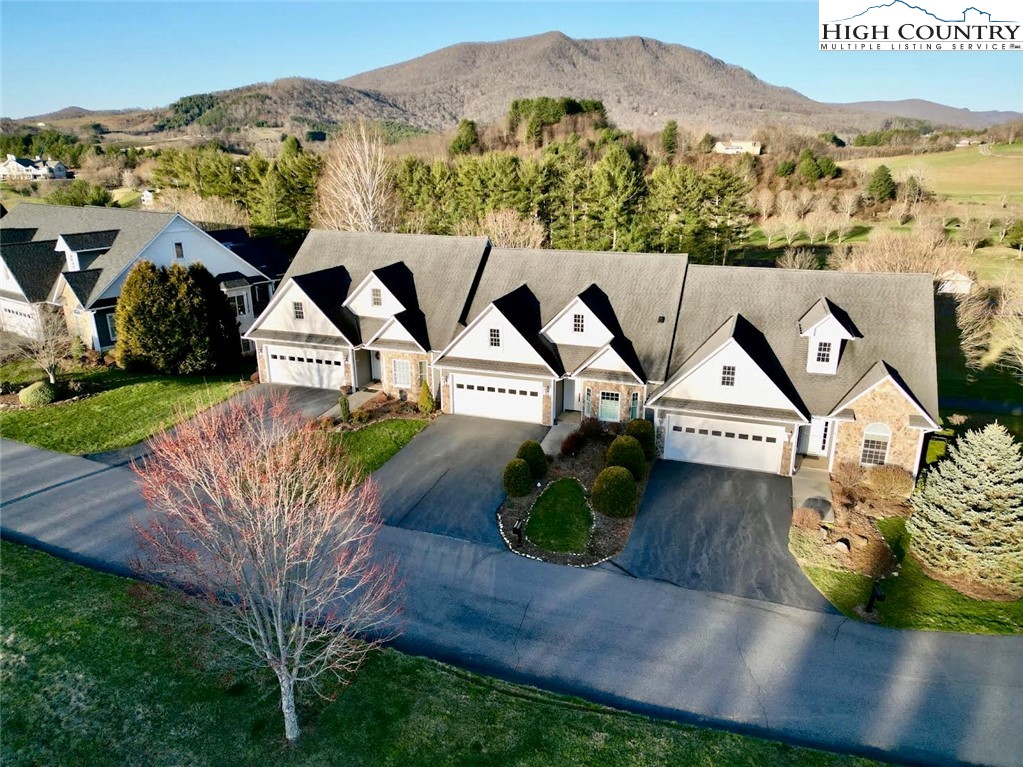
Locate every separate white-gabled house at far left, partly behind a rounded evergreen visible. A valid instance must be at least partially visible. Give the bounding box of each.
[0,205,273,351]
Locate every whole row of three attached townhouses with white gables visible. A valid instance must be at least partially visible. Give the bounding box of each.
[248,231,937,476]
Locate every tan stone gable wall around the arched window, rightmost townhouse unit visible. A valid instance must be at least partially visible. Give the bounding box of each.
[835,380,921,476]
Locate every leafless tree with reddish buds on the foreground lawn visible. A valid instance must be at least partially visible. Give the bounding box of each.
[134,398,398,741]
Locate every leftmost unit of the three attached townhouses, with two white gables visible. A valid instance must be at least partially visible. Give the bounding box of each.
[246,230,490,398]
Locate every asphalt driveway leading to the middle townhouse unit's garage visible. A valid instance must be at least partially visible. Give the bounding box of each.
[373,415,547,547]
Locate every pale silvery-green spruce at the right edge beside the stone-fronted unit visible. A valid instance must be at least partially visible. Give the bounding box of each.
[907,423,1023,597]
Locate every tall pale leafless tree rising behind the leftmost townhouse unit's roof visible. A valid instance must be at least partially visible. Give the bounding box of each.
[314,120,398,232]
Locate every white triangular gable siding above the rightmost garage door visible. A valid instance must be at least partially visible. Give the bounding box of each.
[665,341,792,409]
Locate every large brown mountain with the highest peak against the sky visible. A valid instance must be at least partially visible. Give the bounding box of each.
[341,32,879,132]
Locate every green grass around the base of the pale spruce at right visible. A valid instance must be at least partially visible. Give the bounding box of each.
[805,518,1023,634]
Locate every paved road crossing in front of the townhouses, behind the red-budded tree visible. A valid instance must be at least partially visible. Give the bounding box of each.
[0,441,1023,767]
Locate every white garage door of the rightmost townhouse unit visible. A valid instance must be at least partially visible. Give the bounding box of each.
[664,415,785,473]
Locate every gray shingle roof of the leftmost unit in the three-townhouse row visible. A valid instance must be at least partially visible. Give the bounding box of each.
[284,229,490,350]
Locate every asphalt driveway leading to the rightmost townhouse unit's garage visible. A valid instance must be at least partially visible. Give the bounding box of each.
[613,460,835,613]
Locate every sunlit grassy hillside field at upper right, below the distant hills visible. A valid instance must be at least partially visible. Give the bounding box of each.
[842,145,1023,202]
